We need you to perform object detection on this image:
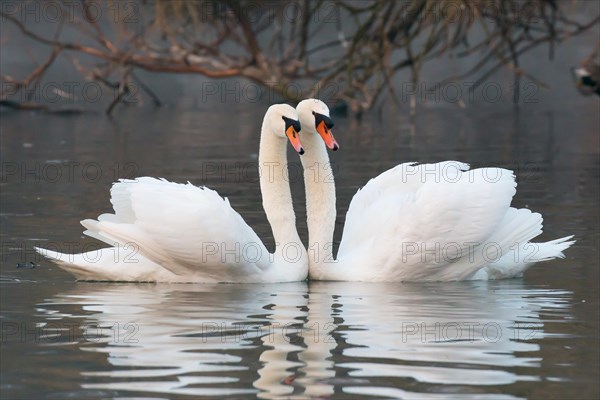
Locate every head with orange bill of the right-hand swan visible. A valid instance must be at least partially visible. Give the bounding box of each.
[296,99,340,151]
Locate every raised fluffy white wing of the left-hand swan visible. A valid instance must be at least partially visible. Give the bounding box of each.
[82,177,270,282]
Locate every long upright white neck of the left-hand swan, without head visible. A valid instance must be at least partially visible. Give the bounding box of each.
[258,118,306,262]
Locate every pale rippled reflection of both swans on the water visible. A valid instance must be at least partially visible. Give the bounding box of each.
[38,281,571,399]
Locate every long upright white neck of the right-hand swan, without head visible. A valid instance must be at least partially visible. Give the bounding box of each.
[301,134,336,269]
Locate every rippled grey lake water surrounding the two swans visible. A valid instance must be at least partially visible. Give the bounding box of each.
[0,13,600,400]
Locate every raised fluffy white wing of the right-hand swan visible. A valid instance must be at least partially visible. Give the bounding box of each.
[334,161,541,281]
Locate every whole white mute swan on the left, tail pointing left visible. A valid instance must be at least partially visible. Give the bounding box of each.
[36,104,308,282]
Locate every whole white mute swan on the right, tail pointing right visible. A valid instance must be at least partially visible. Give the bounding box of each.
[296,99,574,282]
